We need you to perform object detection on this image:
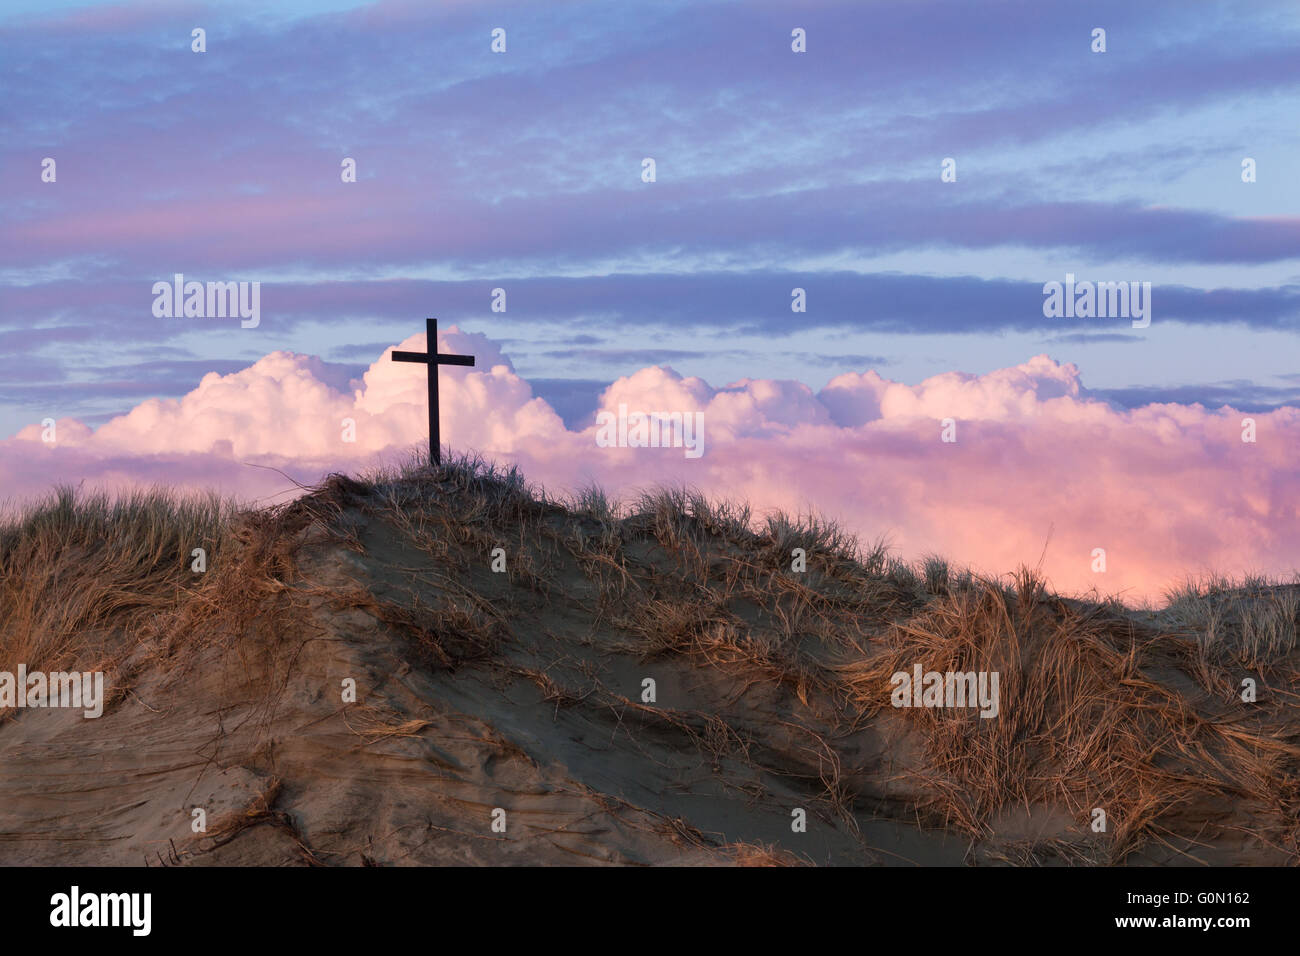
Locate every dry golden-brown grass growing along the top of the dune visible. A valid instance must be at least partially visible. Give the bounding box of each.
[0,455,1300,861]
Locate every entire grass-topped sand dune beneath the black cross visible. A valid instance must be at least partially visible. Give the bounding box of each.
[0,462,1300,866]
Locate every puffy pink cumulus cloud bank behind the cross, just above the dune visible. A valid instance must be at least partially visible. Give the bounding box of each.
[0,326,1300,598]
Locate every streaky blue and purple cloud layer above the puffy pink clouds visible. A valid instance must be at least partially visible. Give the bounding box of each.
[0,0,1300,434]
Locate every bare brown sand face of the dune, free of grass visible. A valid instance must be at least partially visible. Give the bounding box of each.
[0,470,1296,866]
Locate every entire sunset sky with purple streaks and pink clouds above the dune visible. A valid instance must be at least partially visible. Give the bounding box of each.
[0,0,1300,596]
